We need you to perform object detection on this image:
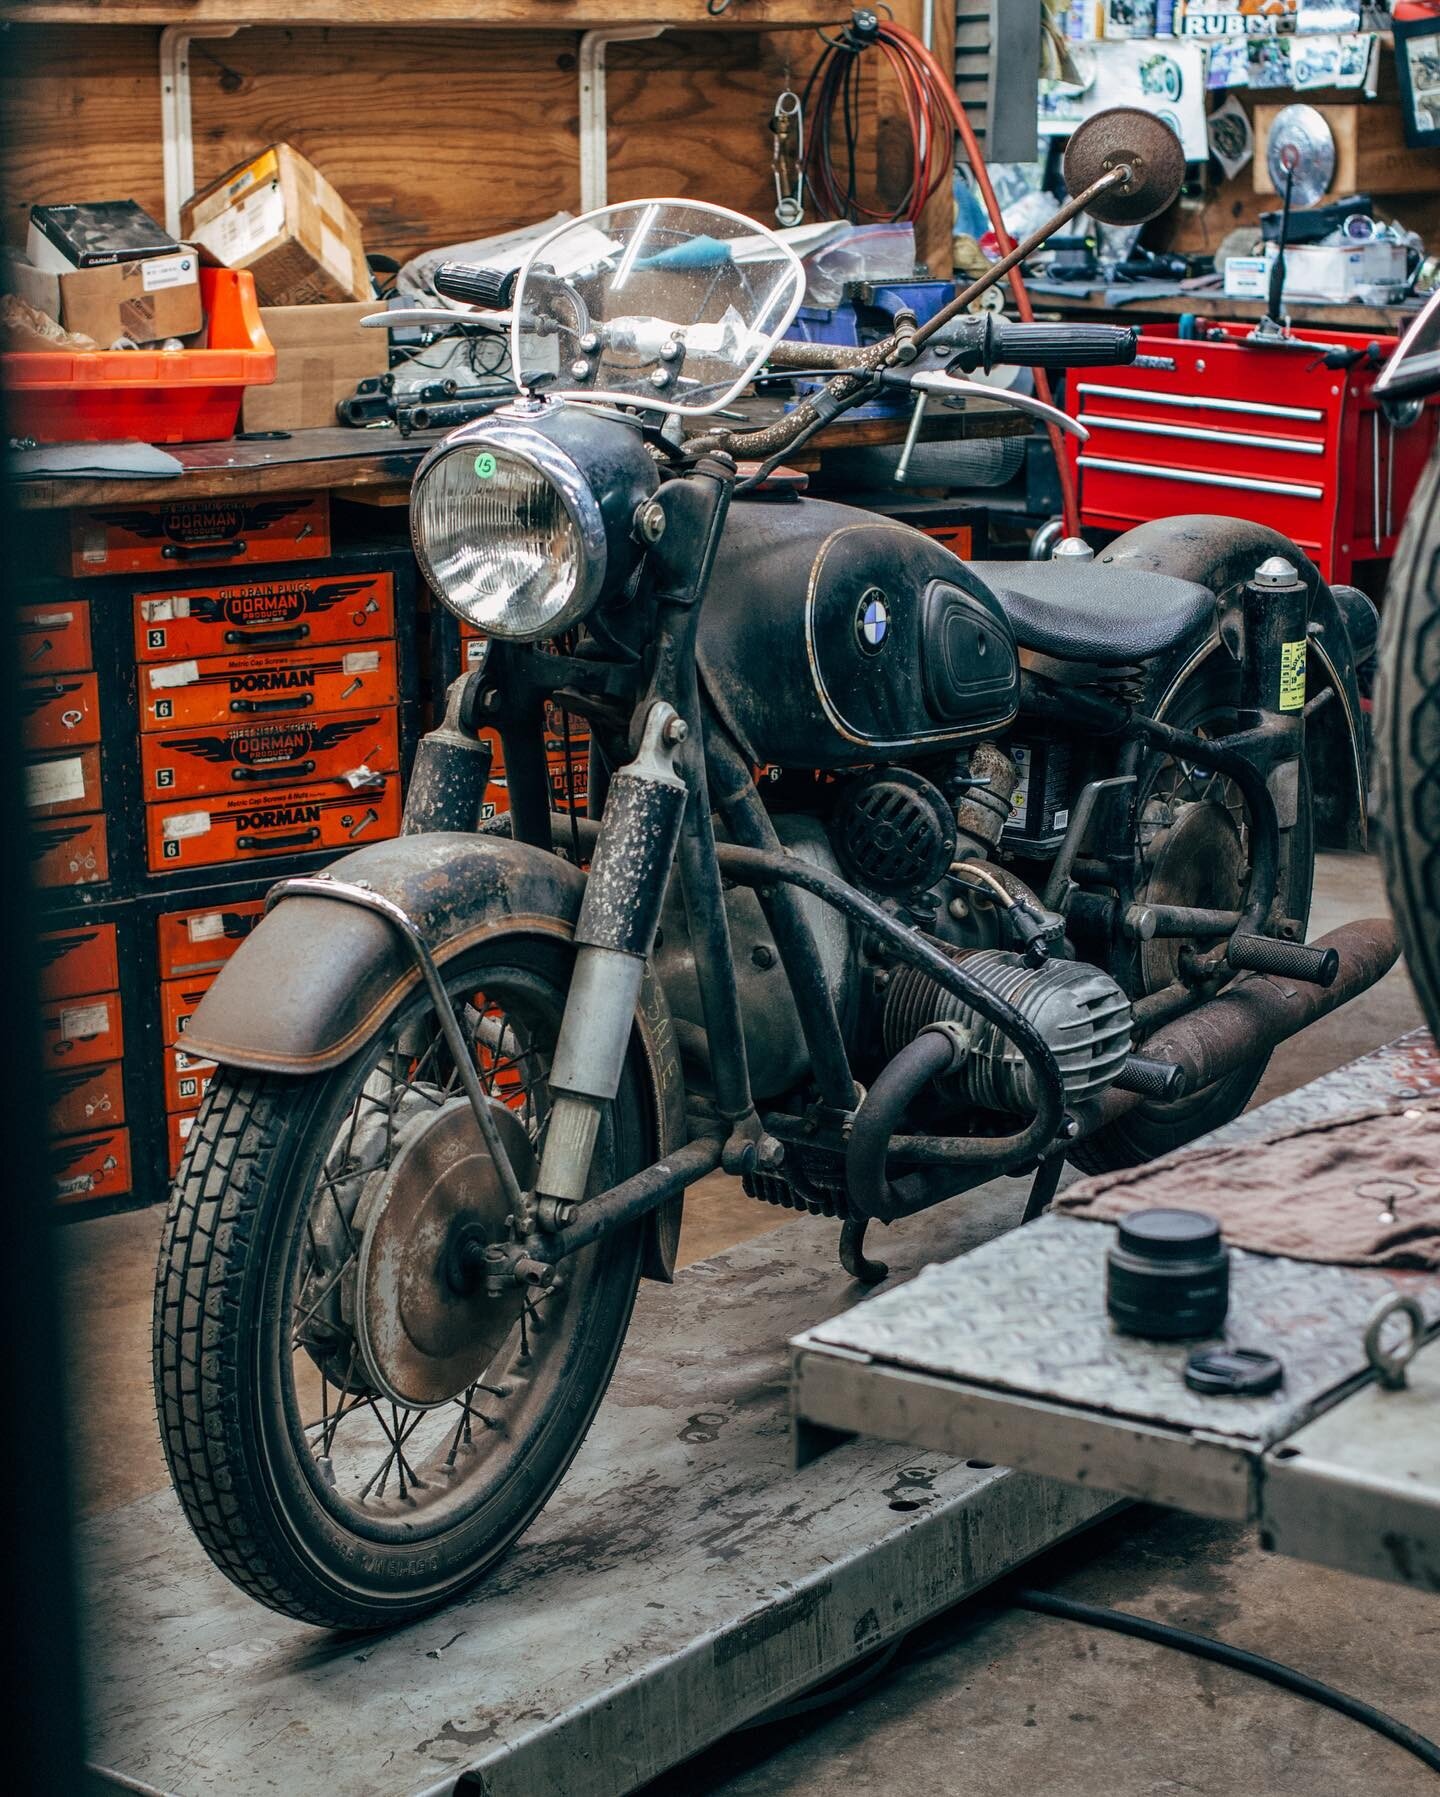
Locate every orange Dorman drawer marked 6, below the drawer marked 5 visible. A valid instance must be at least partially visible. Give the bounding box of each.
[146,778,401,873]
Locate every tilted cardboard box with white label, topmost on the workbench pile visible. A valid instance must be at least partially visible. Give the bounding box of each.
[182,144,374,305]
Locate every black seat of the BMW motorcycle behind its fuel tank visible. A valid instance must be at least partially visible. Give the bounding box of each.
[969,557,1215,667]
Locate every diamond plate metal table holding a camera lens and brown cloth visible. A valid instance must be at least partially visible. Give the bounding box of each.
[791,1030,1440,1590]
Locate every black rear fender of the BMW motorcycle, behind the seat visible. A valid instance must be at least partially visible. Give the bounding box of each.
[1098,514,1368,848]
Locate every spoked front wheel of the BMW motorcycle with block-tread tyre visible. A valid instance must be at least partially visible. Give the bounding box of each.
[155,938,653,1628]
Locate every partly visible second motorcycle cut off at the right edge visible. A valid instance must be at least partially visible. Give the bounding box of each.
[1375,291,1440,1031]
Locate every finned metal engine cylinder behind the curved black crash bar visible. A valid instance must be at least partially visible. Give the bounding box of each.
[883,949,1131,1114]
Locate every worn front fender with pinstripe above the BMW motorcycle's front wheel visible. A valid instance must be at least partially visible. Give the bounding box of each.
[185,832,687,1279]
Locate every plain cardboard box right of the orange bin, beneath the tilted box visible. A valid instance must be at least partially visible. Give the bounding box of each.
[241,300,390,431]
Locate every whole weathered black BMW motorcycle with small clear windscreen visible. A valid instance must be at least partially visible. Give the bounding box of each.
[155,113,1393,1626]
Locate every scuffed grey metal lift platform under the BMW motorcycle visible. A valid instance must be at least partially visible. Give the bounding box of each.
[83,1181,1115,1797]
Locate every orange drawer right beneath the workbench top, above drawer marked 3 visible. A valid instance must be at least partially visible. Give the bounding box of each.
[70,492,331,575]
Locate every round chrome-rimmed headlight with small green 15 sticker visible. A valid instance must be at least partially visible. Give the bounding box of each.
[410,420,606,642]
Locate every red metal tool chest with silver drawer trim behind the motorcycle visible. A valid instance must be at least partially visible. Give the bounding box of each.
[1068,323,1440,582]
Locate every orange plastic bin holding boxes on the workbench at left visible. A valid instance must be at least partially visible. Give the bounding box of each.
[0,268,275,444]
